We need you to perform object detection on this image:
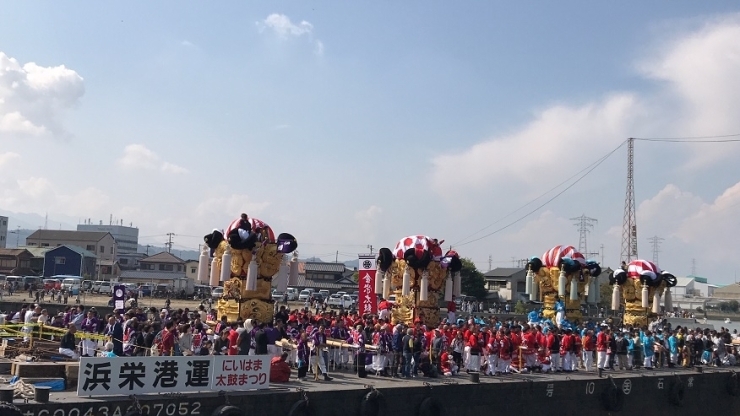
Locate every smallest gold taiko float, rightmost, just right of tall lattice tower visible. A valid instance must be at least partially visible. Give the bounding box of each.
[609,260,677,327]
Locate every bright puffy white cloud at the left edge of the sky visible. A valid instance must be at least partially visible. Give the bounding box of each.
[0,52,85,138]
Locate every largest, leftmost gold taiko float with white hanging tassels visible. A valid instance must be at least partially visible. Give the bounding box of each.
[198,214,298,322]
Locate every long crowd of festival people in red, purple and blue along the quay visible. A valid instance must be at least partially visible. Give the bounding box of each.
[4,305,740,381]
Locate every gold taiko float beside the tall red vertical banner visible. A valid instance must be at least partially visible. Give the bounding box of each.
[375,235,462,326]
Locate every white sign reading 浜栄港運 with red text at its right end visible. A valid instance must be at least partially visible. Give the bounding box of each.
[77,355,271,396]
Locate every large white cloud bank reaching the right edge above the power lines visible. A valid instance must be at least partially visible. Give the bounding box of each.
[432,15,740,196]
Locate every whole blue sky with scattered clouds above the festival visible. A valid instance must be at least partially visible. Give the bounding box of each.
[0,1,740,284]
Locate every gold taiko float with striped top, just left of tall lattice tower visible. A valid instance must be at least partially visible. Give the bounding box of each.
[525,246,601,324]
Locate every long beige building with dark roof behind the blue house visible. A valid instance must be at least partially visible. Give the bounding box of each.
[26,230,117,261]
